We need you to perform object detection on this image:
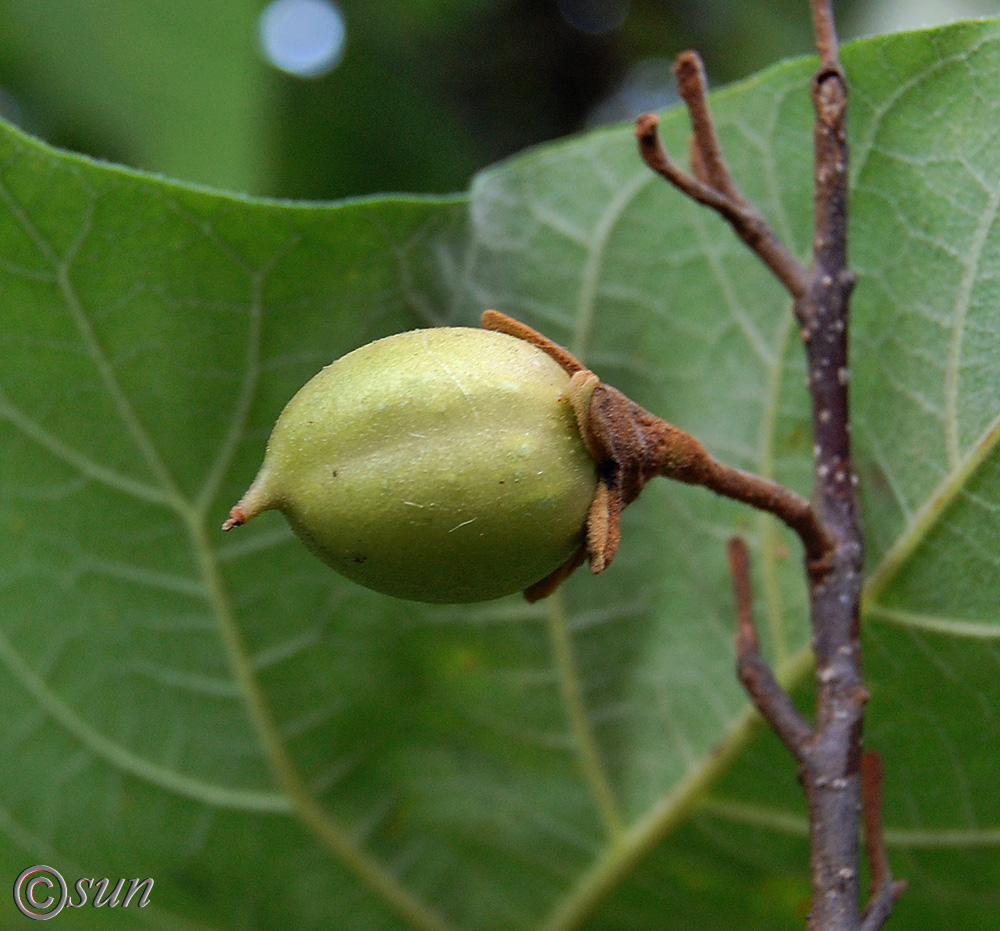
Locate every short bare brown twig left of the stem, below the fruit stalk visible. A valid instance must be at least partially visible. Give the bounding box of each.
[728,537,812,762]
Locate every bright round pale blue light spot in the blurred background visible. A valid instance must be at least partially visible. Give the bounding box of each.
[260,0,347,78]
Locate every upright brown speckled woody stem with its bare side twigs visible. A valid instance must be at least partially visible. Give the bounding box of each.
[636,0,903,931]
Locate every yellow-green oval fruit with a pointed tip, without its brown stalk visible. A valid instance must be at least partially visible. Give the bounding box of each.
[234,327,596,603]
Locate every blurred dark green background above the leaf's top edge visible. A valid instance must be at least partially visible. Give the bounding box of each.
[0,0,1000,200]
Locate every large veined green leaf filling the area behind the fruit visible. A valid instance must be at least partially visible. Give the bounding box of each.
[0,23,1000,931]
